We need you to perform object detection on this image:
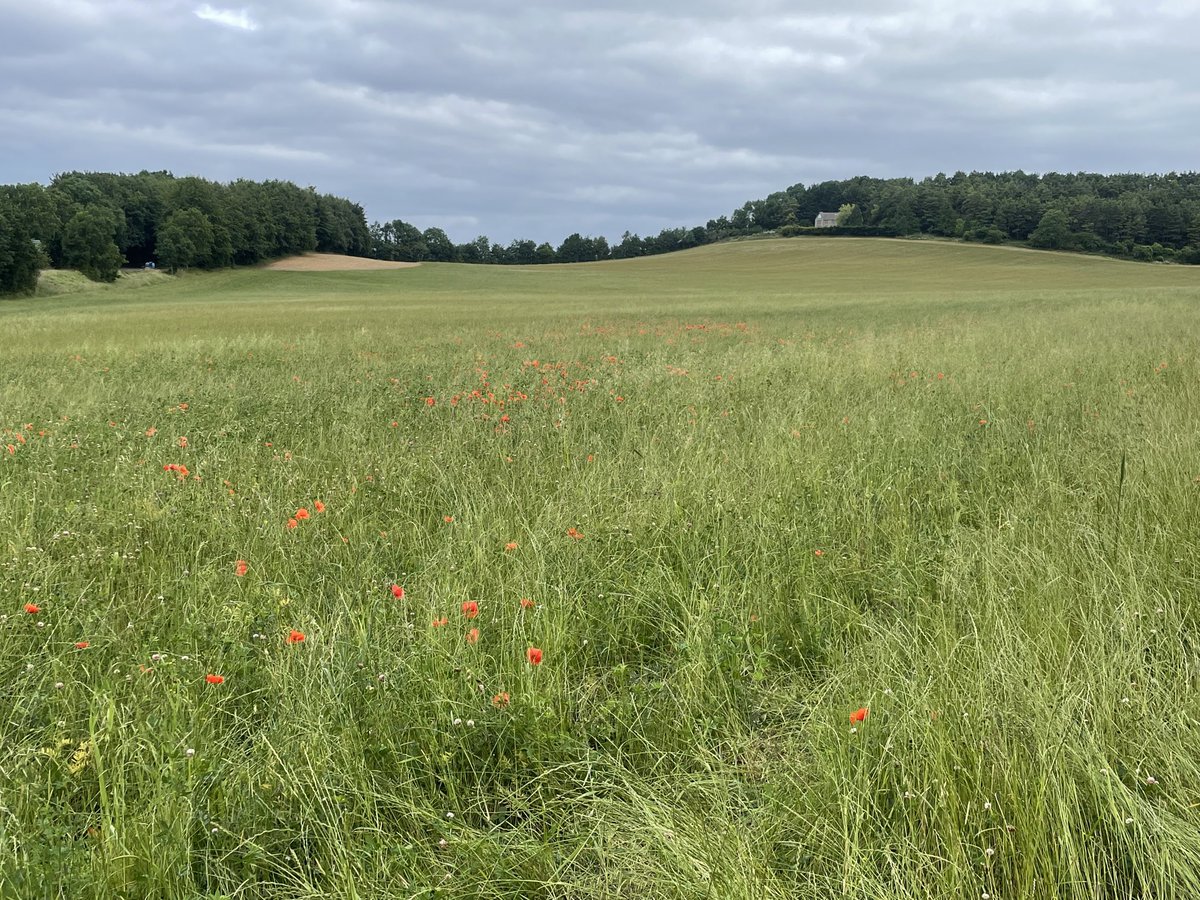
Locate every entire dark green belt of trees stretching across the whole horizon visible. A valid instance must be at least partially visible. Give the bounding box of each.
[0,172,1200,294]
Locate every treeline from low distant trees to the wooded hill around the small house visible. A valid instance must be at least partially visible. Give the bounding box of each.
[371,172,1200,265]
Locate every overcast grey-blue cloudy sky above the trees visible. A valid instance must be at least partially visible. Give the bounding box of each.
[0,0,1200,245]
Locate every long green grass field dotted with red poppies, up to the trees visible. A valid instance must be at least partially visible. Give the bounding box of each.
[0,239,1200,900]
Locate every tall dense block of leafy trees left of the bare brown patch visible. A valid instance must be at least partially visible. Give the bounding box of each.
[0,172,371,294]
